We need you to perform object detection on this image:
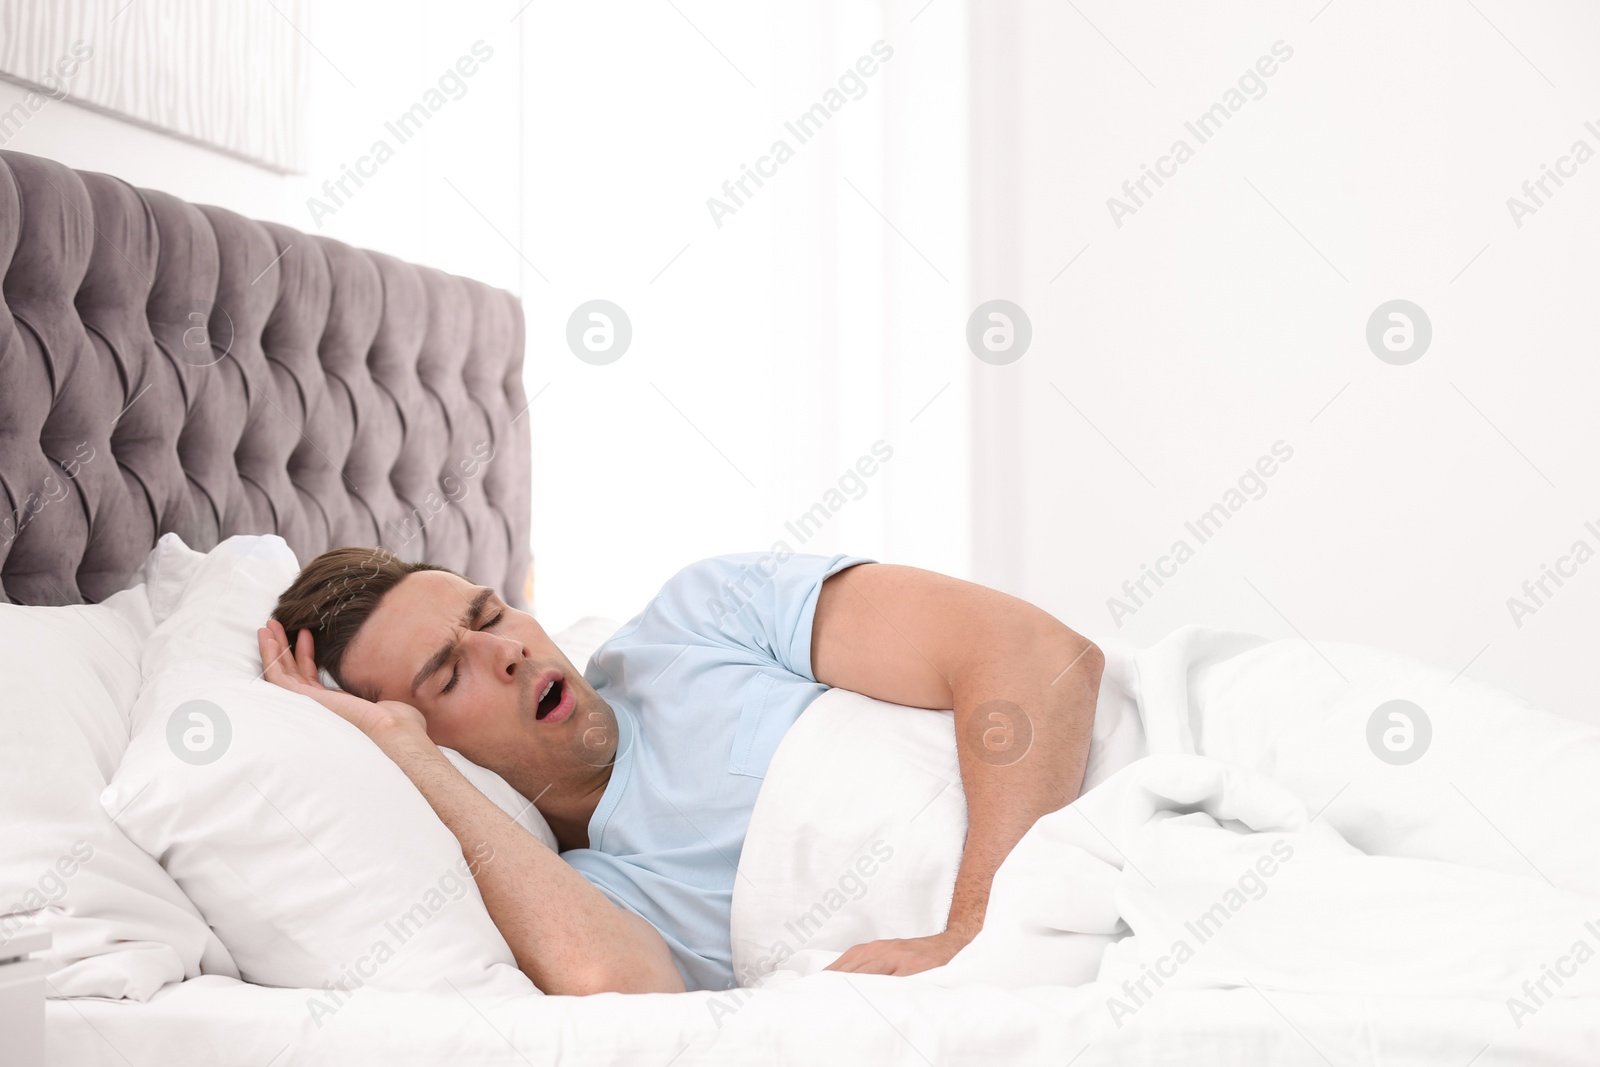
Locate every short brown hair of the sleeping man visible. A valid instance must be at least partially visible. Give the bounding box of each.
[272,545,464,701]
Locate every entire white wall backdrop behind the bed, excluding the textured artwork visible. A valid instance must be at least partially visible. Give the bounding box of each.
[15,0,1600,726]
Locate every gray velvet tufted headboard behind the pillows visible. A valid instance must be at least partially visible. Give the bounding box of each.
[0,152,531,608]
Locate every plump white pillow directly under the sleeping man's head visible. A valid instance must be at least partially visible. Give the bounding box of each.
[101,536,554,1004]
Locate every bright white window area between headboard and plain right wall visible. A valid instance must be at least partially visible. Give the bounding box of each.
[522,0,968,622]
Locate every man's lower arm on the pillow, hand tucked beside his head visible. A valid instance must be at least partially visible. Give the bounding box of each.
[258,621,683,995]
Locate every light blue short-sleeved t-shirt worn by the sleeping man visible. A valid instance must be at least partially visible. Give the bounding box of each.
[562,552,872,990]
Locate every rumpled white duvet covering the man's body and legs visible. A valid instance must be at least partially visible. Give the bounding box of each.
[734,627,1600,1037]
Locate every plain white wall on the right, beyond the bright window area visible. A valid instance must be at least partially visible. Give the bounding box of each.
[973,0,1600,721]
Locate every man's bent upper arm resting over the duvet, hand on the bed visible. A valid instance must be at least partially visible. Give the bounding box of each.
[811,563,1104,974]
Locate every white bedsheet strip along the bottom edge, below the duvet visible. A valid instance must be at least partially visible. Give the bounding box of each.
[46,973,1600,1067]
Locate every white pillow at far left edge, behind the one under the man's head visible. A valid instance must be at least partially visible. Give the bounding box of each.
[0,575,238,1000]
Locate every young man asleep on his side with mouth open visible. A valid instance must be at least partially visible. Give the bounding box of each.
[259,547,1104,993]
